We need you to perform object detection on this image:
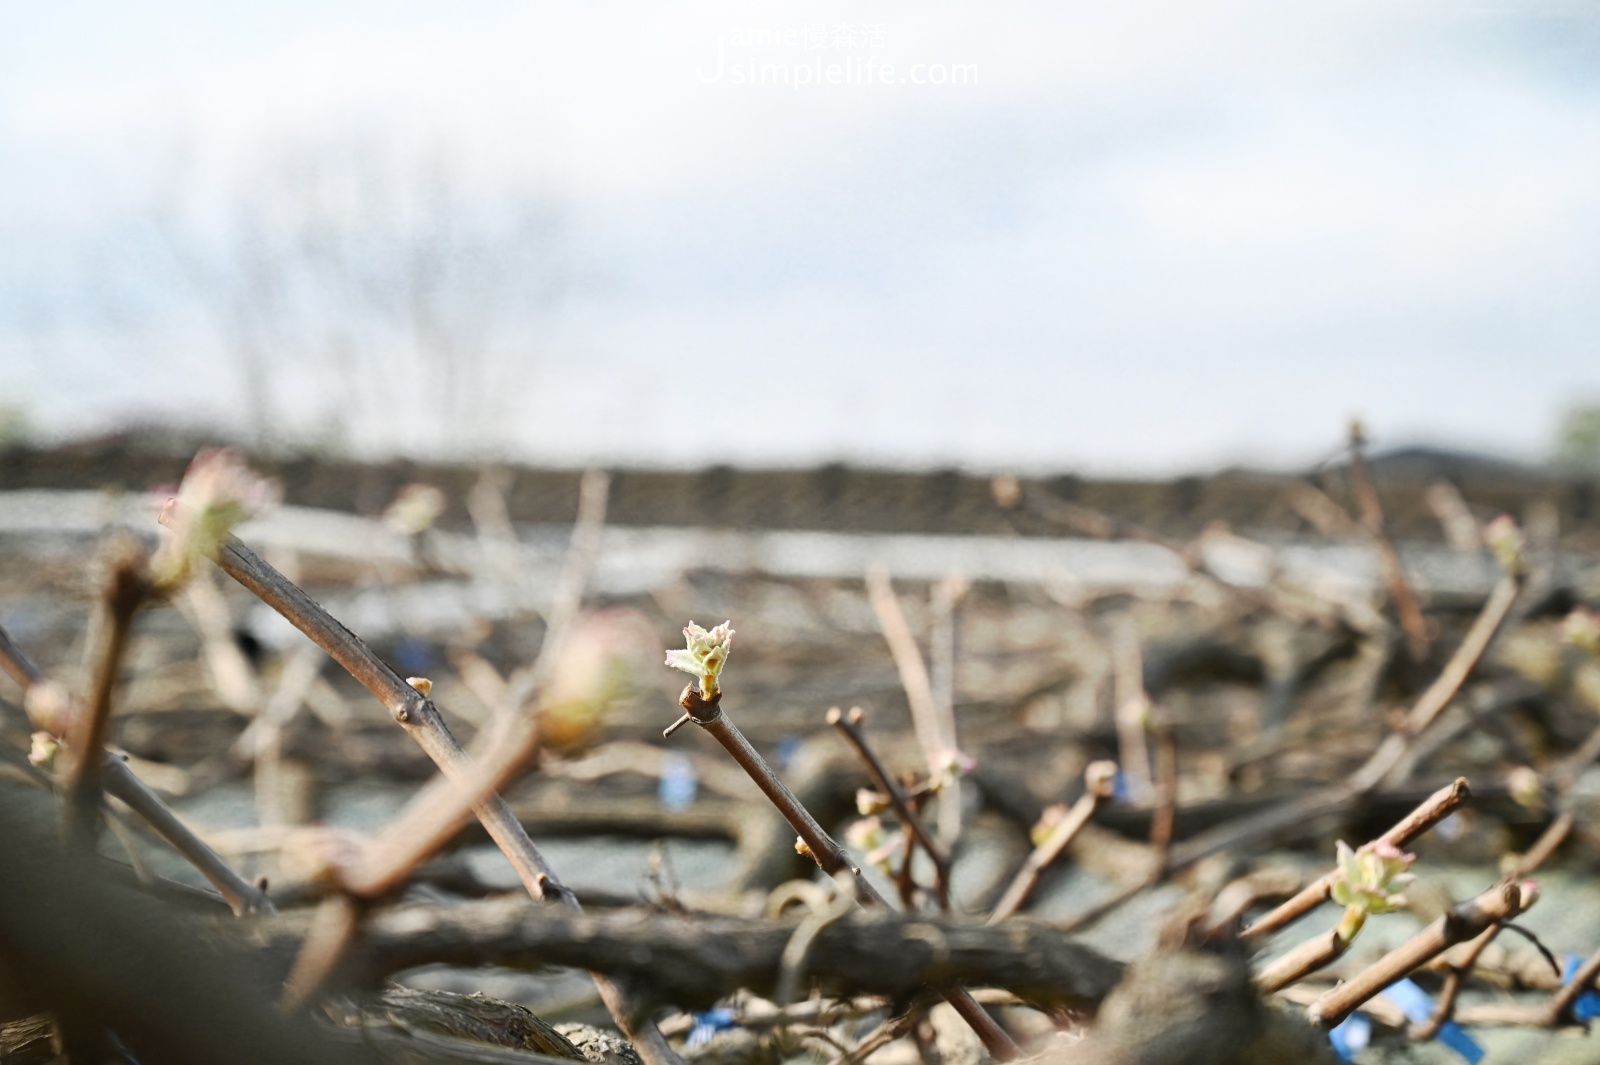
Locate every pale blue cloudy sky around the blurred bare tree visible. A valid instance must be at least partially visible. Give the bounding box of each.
[0,0,1600,473]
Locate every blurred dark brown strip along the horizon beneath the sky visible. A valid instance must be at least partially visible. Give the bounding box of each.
[0,432,1600,547]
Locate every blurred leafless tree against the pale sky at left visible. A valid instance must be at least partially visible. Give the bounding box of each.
[158,141,565,457]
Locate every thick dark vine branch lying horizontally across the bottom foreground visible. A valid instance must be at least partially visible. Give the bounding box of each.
[246,892,1123,1011]
